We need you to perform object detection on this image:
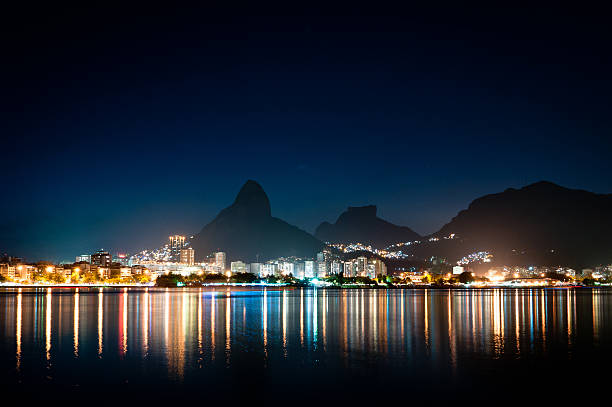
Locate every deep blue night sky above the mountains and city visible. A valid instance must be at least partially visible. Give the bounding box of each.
[0,3,612,261]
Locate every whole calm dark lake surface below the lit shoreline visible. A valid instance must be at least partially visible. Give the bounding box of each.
[0,288,612,405]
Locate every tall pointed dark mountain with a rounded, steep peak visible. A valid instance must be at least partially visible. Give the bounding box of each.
[191,180,323,262]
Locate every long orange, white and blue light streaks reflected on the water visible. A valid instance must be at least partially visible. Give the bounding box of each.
[0,288,612,404]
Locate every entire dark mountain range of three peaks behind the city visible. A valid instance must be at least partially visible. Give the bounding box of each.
[192,180,612,268]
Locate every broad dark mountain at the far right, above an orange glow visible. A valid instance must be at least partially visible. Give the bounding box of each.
[424,181,612,266]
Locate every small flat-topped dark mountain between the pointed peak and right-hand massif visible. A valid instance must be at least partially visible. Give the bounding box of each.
[315,205,421,248]
